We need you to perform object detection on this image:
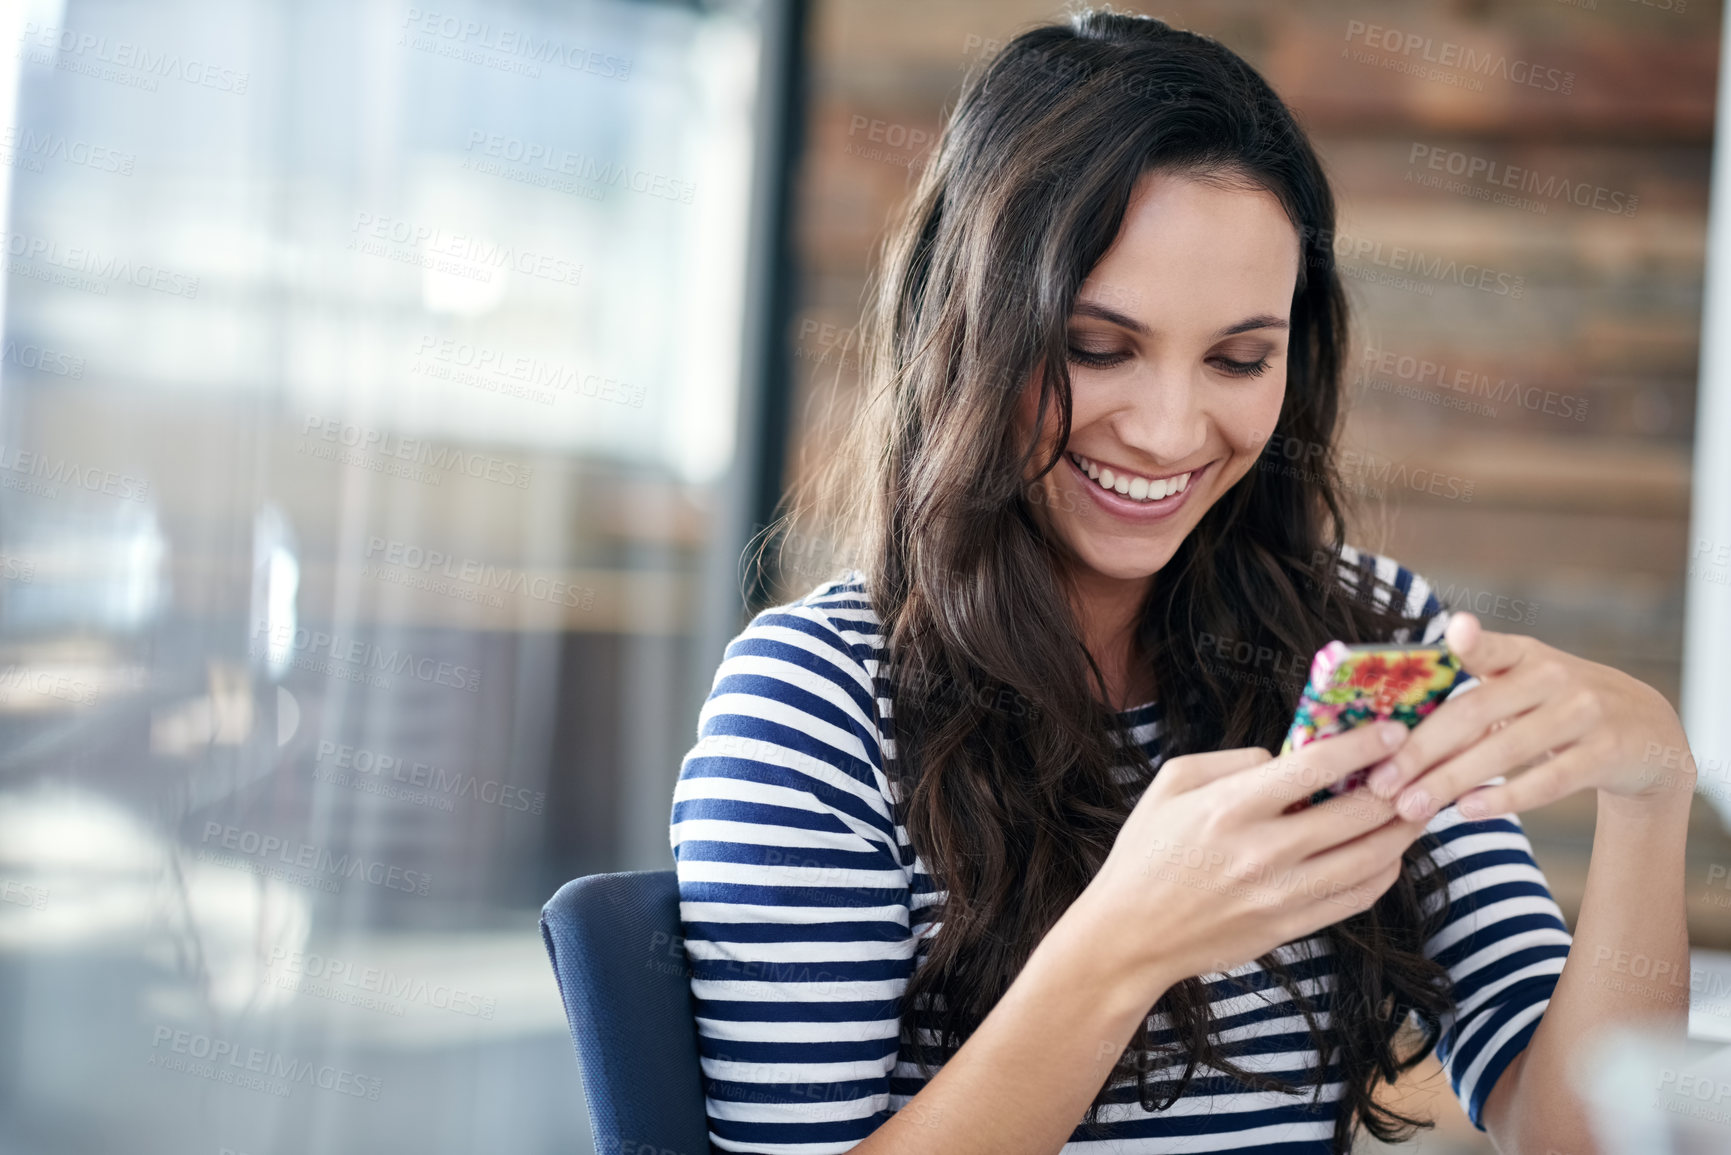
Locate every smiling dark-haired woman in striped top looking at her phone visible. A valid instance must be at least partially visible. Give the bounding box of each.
[670,12,1686,1155]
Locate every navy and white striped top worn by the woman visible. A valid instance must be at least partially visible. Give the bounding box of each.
[668,545,1570,1155]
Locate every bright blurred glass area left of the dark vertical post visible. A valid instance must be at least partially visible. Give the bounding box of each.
[0,0,775,1155]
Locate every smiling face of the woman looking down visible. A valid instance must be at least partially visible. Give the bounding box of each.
[1018,173,1300,580]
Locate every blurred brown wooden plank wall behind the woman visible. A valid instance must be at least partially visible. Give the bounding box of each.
[782,0,1731,1150]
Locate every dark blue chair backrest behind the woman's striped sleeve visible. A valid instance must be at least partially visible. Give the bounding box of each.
[542,871,710,1155]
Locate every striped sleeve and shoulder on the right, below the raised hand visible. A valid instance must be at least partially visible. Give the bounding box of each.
[1342,545,1572,1131]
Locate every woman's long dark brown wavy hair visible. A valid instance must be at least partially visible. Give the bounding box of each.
[775,12,1452,1155]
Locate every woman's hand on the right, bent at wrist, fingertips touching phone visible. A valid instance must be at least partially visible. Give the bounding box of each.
[1366,613,1695,821]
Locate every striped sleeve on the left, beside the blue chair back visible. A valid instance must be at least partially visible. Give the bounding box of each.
[668,599,917,1155]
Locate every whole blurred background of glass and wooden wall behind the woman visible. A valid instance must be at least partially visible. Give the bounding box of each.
[0,0,1731,1155]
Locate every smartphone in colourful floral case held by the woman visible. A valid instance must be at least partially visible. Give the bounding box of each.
[1281,642,1470,814]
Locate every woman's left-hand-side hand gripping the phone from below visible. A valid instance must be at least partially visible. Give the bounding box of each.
[1082,722,1426,989]
